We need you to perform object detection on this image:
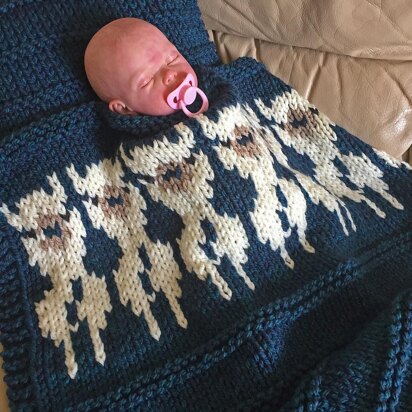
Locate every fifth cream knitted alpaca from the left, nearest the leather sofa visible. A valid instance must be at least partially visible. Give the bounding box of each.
[256,90,403,229]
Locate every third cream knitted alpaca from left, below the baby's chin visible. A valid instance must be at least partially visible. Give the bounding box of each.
[120,124,254,299]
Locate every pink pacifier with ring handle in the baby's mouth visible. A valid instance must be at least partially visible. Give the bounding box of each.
[166,73,209,117]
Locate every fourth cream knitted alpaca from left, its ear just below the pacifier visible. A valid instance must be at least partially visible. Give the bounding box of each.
[197,105,314,268]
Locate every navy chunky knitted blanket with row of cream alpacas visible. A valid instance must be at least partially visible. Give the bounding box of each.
[0,0,412,411]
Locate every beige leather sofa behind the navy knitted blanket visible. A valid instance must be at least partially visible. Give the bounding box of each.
[0,0,412,412]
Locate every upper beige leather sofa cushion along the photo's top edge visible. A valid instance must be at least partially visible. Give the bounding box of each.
[198,0,412,60]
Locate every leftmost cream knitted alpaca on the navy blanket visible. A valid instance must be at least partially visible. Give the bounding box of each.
[0,173,112,378]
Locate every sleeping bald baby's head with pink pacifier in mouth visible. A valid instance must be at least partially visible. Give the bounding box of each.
[84,18,208,116]
